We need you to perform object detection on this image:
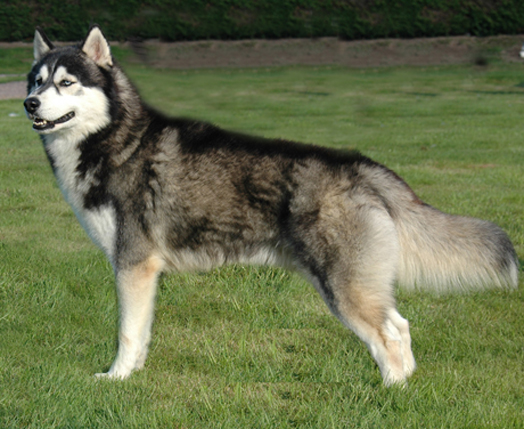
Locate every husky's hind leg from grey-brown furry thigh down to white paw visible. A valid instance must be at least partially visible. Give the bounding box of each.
[292,202,415,386]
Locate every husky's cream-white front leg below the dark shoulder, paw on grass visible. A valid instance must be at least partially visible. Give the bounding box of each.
[97,256,164,379]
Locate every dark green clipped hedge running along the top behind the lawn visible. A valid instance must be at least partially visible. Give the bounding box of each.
[0,0,524,41]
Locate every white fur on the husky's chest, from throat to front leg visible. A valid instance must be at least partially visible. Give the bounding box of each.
[45,136,116,261]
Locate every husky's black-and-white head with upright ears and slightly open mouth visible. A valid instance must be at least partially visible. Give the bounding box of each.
[24,26,113,136]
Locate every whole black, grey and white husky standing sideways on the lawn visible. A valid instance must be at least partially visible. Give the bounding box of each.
[24,26,518,385]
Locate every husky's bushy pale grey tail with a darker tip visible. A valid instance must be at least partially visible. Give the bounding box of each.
[364,162,519,292]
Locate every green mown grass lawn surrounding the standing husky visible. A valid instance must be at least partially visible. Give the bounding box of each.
[0,49,524,428]
